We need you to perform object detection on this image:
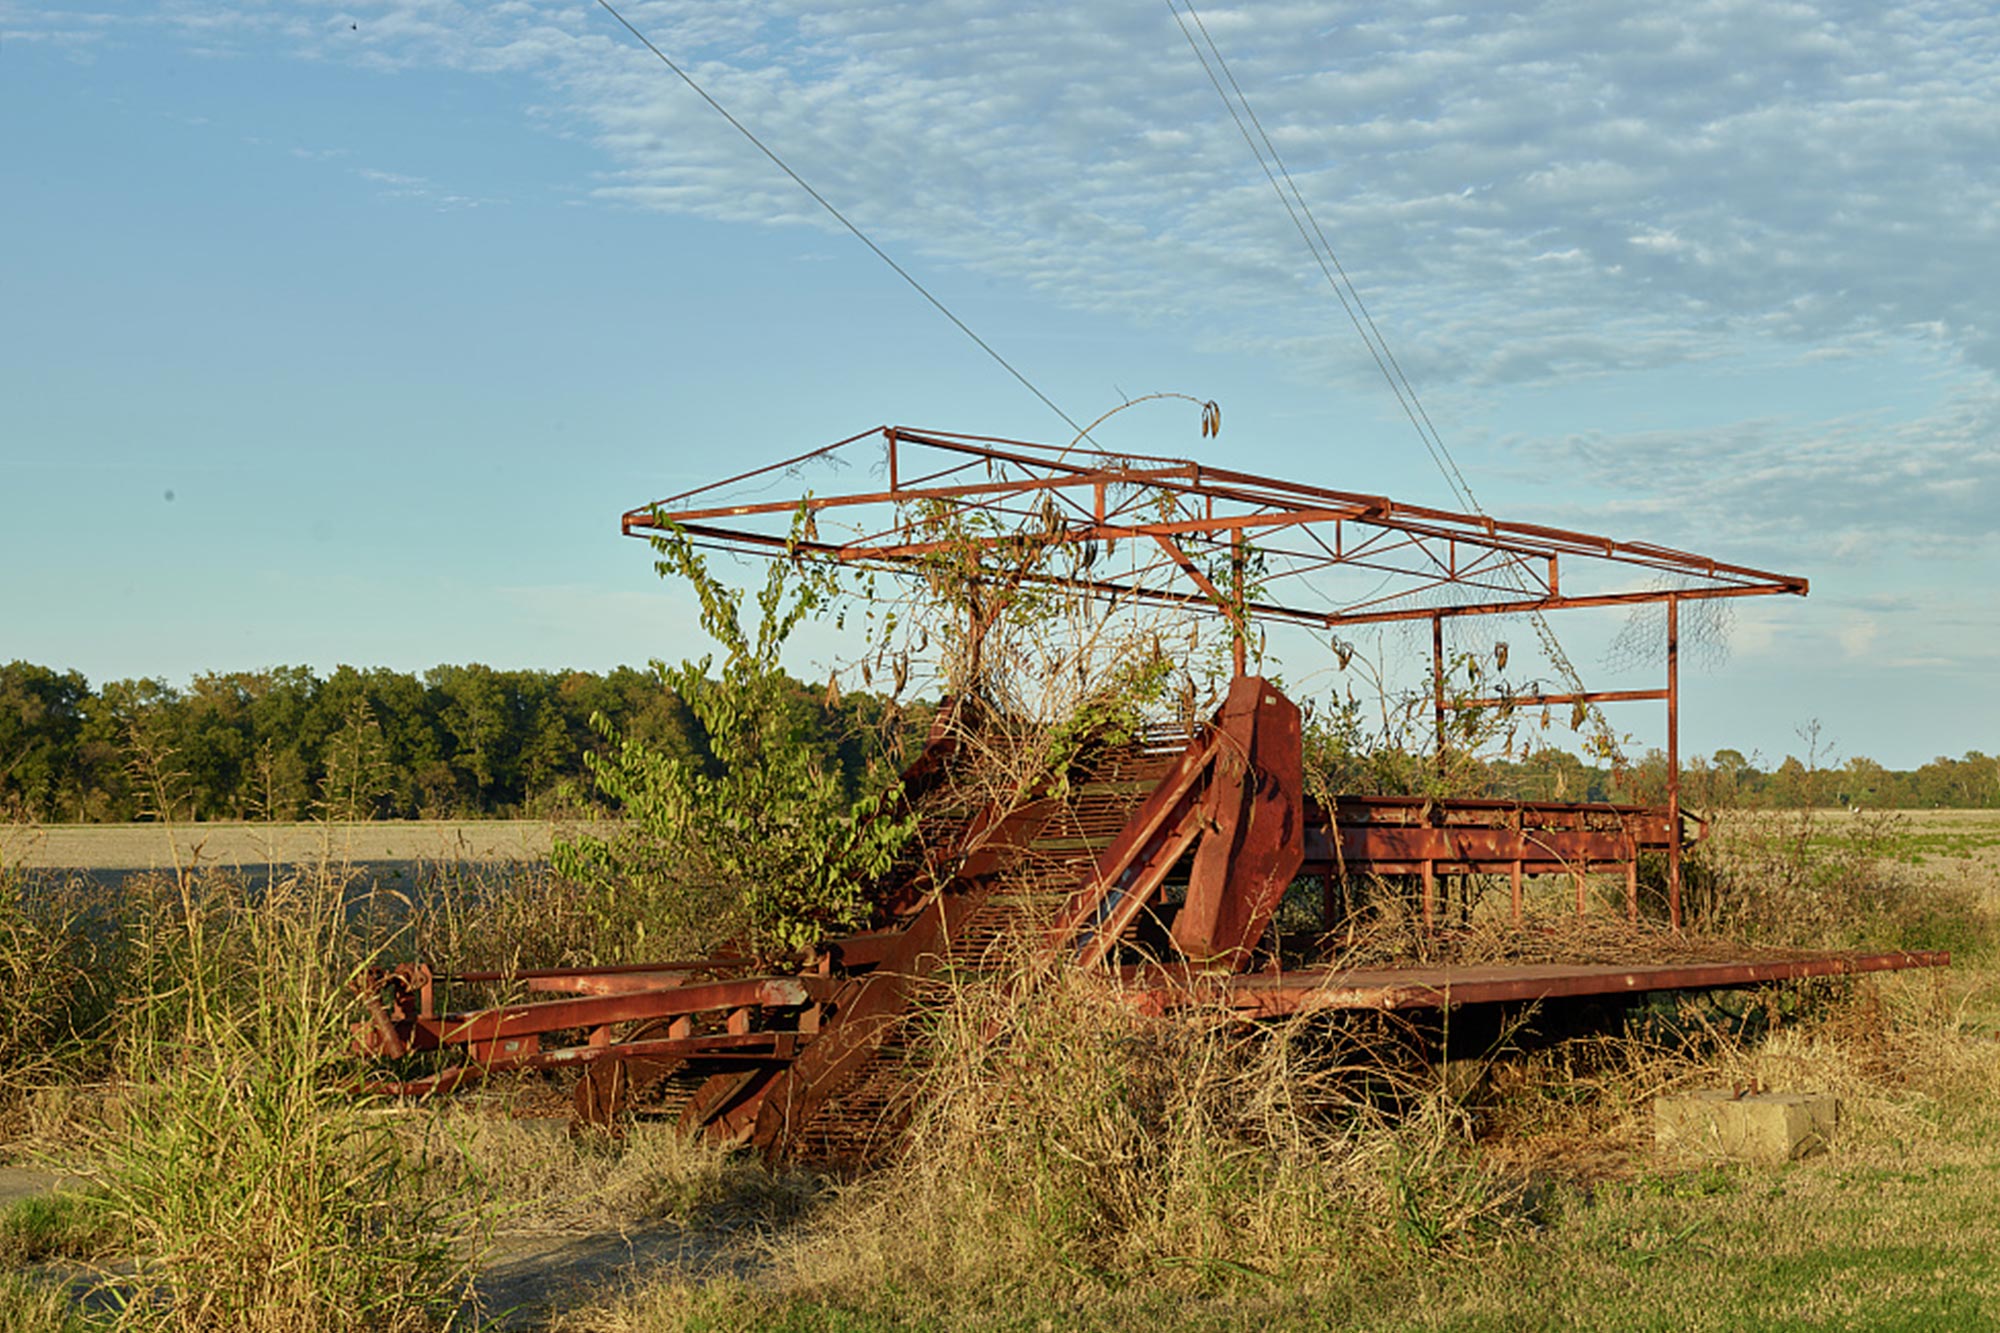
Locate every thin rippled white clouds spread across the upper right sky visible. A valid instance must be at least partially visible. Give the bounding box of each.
[54,0,2000,580]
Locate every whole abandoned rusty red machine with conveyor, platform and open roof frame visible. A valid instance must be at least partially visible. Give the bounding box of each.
[358,428,1948,1161]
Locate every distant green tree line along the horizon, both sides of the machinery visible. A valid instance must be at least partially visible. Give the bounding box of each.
[0,662,2000,823]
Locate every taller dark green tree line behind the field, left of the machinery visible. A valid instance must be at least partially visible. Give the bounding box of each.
[0,662,928,823]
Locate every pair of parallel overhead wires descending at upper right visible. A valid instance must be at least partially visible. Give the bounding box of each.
[1166,0,1618,755]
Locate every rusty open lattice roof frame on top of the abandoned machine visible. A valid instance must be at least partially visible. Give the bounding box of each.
[624,426,1808,630]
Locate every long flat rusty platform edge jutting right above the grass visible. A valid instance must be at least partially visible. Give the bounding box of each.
[1120,951,1952,1019]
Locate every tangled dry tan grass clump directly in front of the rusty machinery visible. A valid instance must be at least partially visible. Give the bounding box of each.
[764,956,1518,1311]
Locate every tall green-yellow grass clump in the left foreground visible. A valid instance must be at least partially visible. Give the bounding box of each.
[86,875,472,1333]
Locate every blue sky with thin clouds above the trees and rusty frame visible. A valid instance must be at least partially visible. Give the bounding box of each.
[0,0,2000,767]
